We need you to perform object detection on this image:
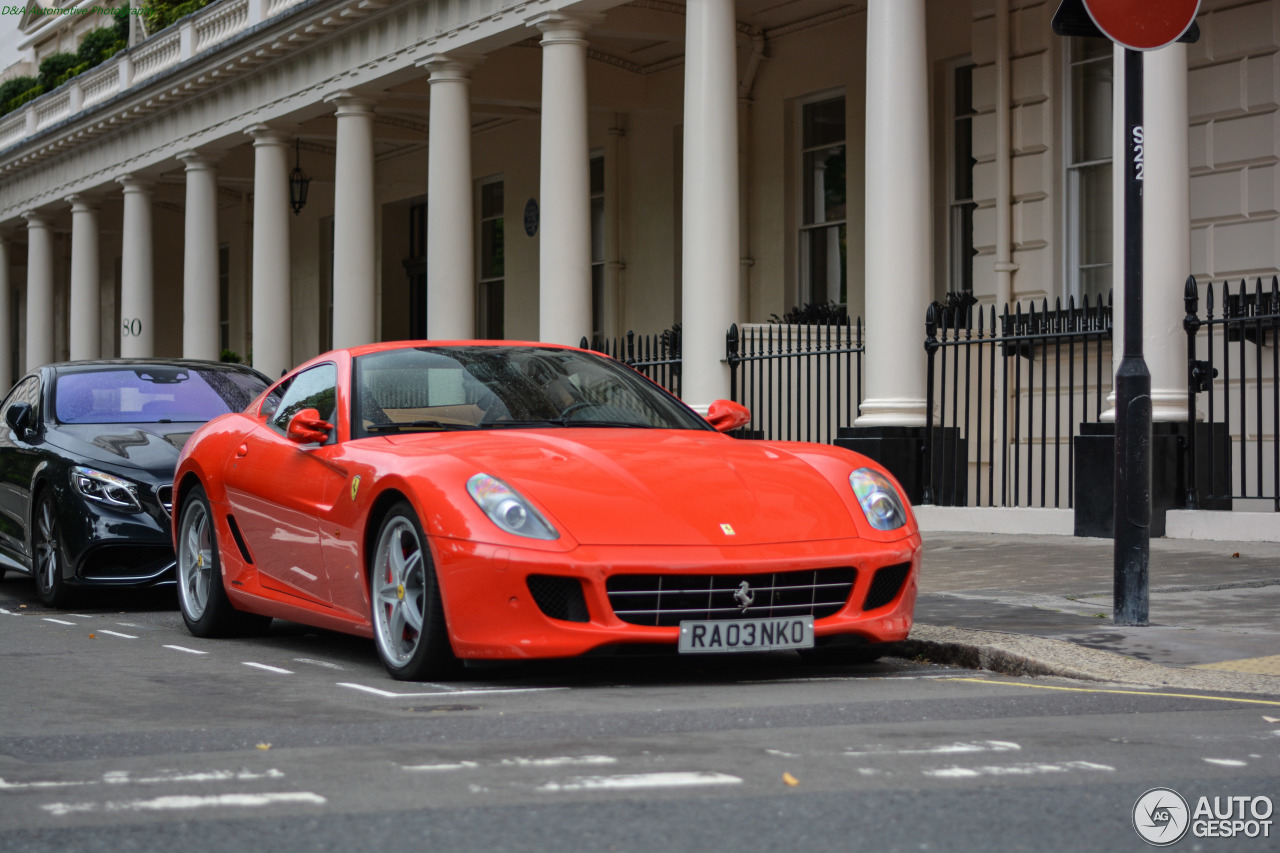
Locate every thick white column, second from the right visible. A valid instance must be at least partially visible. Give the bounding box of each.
[856,0,933,427]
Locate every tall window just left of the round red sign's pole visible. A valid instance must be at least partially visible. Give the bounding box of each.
[1065,38,1114,301]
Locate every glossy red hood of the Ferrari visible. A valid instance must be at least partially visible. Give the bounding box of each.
[394,429,858,546]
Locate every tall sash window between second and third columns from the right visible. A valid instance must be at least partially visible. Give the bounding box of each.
[800,96,849,305]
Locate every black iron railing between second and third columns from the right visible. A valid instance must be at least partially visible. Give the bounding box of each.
[726,318,864,443]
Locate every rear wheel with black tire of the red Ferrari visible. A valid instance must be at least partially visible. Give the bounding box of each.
[174,485,271,637]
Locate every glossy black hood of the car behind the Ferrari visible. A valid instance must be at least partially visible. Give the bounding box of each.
[46,423,198,478]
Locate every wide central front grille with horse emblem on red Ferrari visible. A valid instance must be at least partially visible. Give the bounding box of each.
[605,567,858,625]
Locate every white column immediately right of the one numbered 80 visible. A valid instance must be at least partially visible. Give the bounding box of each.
[178,151,221,361]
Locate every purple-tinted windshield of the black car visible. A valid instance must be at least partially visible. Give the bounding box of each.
[54,365,266,424]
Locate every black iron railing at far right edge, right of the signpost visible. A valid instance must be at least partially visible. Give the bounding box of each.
[1183,275,1280,511]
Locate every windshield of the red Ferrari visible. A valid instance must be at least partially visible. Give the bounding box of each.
[353,346,710,435]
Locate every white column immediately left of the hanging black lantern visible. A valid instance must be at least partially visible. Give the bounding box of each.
[247,124,293,379]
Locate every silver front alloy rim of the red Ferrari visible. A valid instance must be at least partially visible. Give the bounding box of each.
[371,516,426,667]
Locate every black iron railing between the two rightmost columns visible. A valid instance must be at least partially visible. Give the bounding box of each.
[923,296,1112,507]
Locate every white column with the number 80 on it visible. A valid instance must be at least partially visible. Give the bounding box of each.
[119,175,155,359]
